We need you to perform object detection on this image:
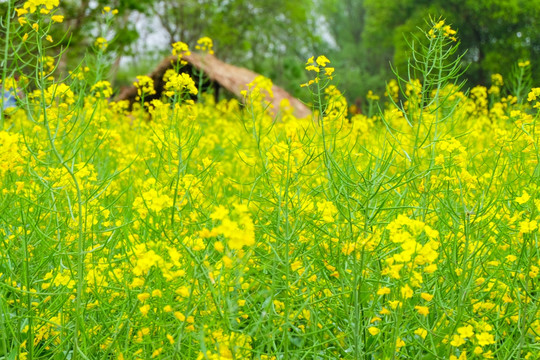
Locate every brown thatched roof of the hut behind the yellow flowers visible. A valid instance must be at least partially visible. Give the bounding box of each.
[117,53,311,118]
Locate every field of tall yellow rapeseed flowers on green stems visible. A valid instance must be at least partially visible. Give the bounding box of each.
[0,0,540,360]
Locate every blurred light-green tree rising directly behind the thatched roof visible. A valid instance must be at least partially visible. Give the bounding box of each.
[149,0,317,97]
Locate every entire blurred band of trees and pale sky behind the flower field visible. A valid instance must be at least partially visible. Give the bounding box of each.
[0,0,540,103]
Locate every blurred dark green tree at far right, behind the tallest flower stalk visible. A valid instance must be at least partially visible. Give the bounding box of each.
[364,0,540,84]
